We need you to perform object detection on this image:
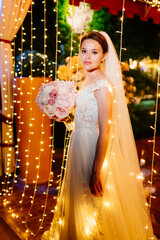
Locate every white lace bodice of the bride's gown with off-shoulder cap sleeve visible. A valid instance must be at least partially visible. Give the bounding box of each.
[74,79,111,129]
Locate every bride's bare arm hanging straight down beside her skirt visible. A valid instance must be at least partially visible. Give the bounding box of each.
[90,88,113,196]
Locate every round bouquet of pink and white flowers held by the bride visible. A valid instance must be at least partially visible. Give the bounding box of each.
[36,81,77,121]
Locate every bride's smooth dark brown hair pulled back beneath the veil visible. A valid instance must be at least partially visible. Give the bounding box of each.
[80,31,108,53]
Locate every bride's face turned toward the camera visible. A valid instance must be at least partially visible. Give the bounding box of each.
[80,39,106,72]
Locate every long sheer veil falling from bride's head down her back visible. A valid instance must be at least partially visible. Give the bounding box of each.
[100,32,155,239]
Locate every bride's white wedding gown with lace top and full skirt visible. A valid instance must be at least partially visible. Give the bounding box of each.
[42,79,156,240]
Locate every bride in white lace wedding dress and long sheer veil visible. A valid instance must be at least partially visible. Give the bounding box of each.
[42,31,156,240]
